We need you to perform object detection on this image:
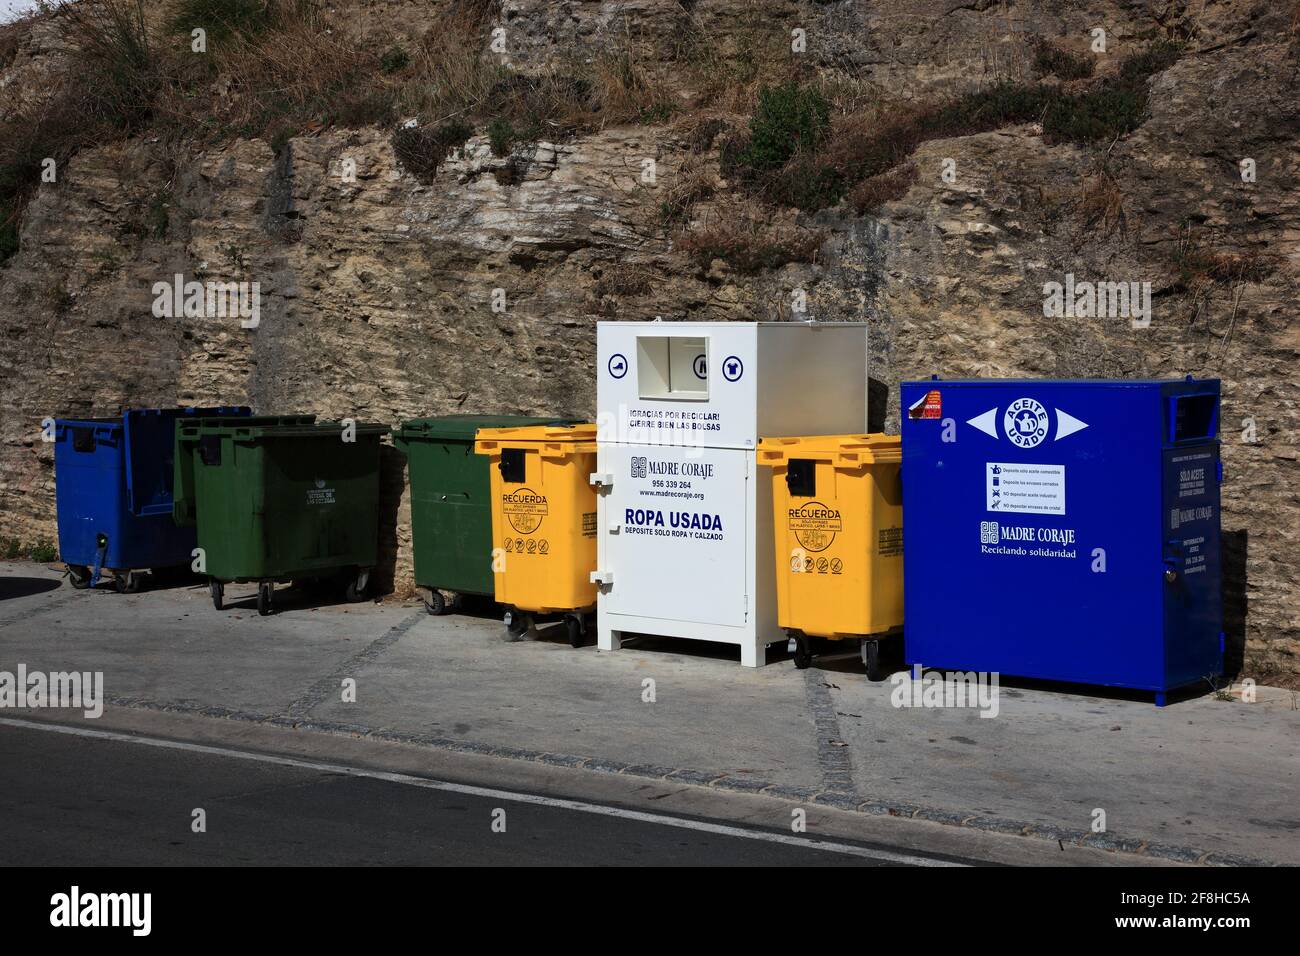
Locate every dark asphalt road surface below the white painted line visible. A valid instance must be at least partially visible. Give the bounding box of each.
[0,724,977,866]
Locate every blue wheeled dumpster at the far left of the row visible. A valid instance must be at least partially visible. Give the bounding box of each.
[55,407,251,593]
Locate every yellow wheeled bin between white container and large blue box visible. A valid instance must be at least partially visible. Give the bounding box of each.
[758,434,902,680]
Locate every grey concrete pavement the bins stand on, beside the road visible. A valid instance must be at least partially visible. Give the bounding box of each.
[0,563,1300,864]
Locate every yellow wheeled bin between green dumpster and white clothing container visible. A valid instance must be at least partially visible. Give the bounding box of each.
[475,424,597,648]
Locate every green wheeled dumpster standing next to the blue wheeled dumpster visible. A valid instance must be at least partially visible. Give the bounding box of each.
[173,415,389,614]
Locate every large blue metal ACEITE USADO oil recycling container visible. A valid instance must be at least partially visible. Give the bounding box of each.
[901,377,1223,706]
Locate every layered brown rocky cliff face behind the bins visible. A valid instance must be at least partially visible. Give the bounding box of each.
[0,0,1300,679]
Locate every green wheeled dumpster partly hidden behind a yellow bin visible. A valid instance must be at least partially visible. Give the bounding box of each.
[393,415,582,614]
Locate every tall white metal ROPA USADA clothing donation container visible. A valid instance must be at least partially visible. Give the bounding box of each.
[592,321,867,667]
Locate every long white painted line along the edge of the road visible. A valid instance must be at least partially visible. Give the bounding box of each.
[0,717,967,866]
